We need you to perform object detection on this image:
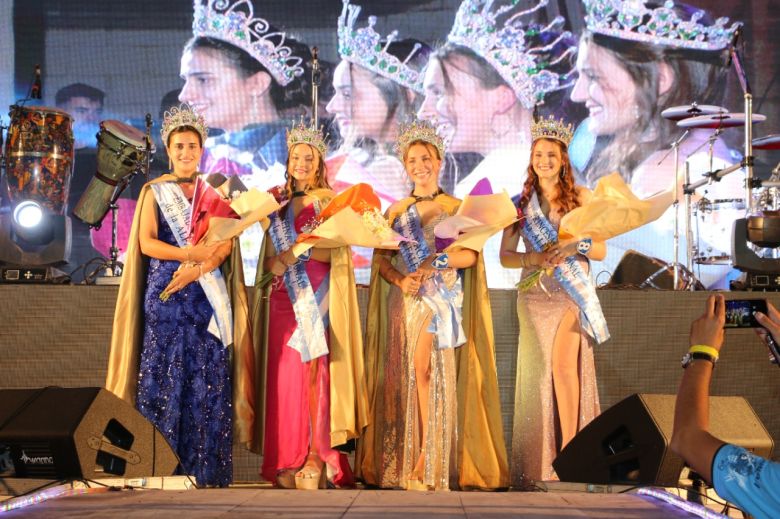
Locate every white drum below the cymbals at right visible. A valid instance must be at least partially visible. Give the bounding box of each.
[694,198,745,265]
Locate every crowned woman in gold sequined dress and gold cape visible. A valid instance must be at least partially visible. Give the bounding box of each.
[356,122,508,490]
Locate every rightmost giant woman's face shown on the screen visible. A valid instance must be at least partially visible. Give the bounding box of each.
[571,41,637,135]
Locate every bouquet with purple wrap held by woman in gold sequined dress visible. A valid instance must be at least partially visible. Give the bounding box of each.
[433,178,520,252]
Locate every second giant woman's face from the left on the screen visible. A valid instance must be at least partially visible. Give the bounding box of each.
[325,60,388,142]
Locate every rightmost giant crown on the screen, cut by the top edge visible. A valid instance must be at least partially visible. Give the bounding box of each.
[583,0,741,51]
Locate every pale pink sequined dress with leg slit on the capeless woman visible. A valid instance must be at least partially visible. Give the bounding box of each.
[510,209,600,488]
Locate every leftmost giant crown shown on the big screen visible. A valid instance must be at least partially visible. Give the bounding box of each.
[192,0,303,86]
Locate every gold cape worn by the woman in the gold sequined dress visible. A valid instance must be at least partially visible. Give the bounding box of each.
[355,194,509,489]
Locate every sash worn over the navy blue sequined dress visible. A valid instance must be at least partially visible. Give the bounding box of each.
[151,179,233,346]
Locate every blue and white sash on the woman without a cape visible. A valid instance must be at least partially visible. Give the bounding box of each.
[523,193,609,344]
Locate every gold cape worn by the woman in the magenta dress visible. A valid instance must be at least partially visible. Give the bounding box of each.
[252,189,368,448]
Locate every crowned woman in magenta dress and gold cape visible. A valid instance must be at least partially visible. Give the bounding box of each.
[256,123,367,489]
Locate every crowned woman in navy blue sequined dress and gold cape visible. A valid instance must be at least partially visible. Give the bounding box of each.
[106,106,254,486]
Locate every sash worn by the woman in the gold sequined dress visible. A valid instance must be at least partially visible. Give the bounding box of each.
[393,204,466,349]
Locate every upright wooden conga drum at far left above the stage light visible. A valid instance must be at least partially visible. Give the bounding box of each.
[5,105,73,215]
